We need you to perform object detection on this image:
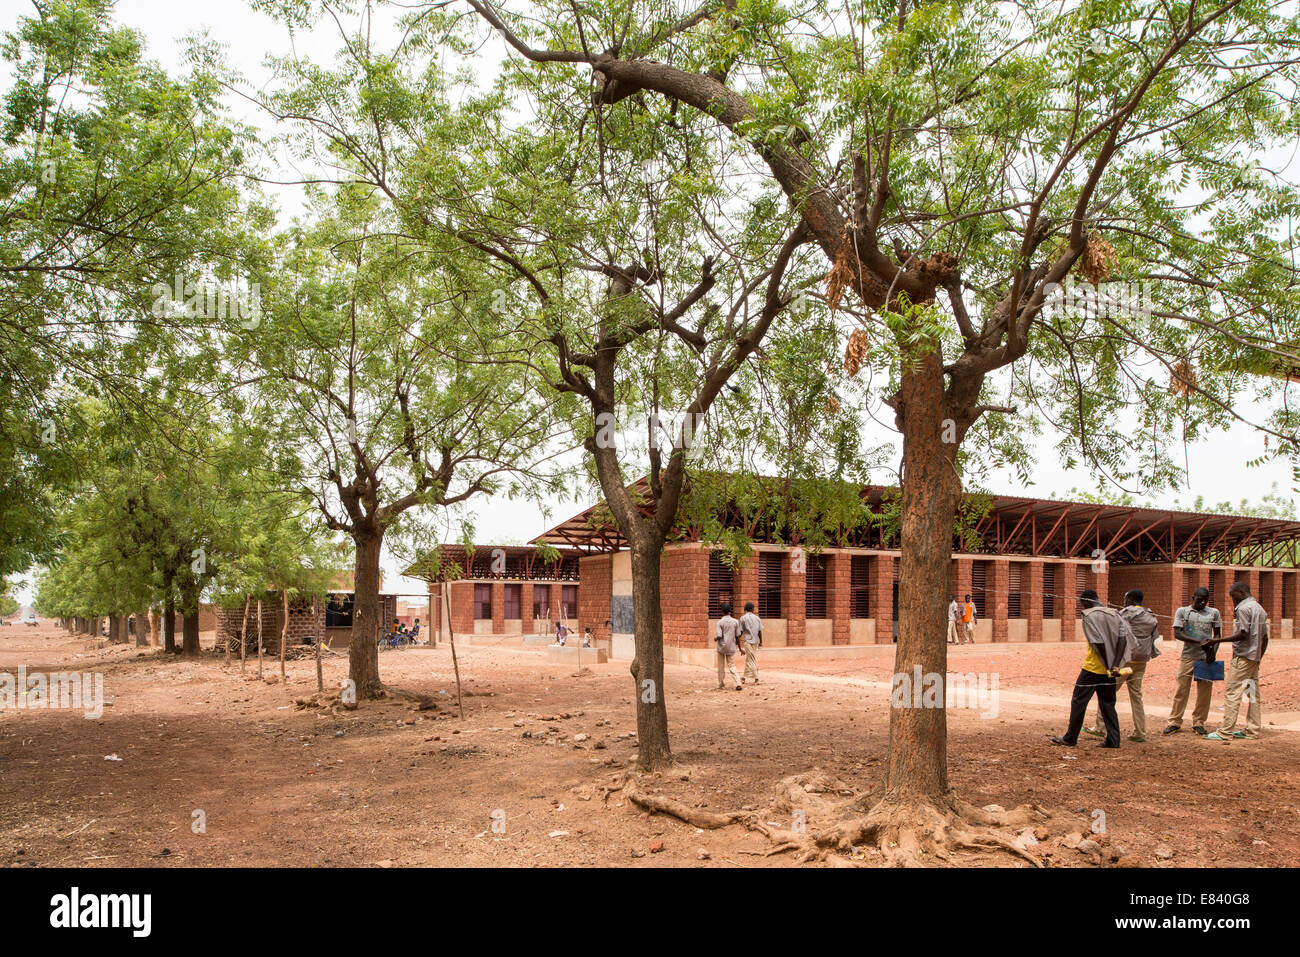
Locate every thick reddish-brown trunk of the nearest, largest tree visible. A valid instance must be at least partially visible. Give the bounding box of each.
[884,354,965,804]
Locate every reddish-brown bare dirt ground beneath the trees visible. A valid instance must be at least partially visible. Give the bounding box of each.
[0,627,1300,867]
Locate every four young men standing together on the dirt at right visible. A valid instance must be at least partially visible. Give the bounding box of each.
[1049,581,1269,748]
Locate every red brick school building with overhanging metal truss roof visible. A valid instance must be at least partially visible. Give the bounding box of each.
[406,486,1300,663]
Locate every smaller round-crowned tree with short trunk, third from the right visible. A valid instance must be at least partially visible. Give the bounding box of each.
[231,186,549,698]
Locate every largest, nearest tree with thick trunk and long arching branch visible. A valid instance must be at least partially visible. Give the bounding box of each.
[465,0,1300,861]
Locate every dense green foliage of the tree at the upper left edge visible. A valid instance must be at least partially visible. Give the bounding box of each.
[0,0,267,573]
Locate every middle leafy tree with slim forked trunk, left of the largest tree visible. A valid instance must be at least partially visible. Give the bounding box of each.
[239,3,863,768]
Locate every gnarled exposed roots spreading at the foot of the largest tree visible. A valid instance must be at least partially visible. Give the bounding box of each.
[601,770,1058,867]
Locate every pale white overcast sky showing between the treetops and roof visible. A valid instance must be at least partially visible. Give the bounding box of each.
[0,0,1291,601]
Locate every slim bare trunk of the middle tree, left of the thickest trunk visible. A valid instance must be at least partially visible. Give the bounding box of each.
[631,542,672,771]
